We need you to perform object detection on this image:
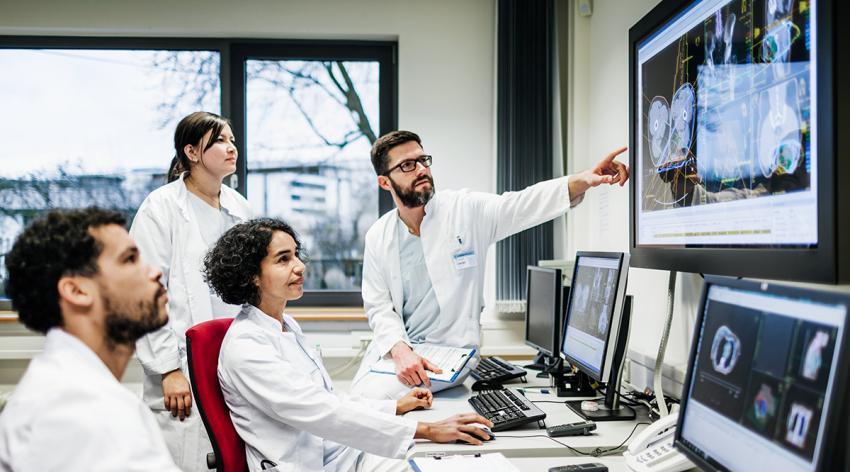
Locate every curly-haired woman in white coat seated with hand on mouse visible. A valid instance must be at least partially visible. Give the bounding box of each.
[204,218,492,472]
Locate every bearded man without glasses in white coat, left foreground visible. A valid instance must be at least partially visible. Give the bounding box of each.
[0,208,179,472]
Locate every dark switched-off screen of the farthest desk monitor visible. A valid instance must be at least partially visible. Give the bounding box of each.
[525,266,561,356]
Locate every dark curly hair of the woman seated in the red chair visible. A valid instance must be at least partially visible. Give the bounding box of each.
[204,218,303,306]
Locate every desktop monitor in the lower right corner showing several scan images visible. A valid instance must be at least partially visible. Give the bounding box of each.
[675,276,850,472]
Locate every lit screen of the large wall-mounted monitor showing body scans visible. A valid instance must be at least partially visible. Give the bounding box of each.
[635,0,819,251]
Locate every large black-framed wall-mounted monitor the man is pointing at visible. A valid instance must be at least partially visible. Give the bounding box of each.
[629,0,850,282]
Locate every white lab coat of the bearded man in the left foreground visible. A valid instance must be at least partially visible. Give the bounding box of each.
[0,328,179,472]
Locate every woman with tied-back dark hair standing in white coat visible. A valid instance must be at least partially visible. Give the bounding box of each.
[130,112,250,471]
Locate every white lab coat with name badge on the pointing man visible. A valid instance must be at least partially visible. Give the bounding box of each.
[358,177,582,360]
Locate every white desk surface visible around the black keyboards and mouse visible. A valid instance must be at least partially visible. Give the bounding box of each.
[405,372,649,460]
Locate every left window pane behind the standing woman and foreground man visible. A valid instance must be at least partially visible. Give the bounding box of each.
[0,49,220,298]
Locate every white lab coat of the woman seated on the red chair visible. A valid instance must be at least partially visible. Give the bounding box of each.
[218,305,416,472]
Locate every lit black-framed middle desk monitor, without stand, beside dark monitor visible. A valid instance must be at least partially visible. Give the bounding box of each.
[561,252,628,380]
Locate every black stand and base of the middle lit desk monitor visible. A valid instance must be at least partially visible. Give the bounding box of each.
[558,296,635,421]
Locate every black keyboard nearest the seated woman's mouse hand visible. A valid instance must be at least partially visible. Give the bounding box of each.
[469,388,546,431]
